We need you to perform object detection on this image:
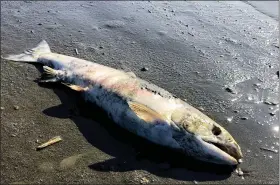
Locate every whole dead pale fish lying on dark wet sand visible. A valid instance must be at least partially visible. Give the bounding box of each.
[1,40,242,165]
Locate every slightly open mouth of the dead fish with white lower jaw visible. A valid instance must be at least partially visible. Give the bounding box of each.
[203,140,242,165]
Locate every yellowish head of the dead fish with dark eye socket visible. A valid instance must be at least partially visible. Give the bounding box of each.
[171,108,243,165]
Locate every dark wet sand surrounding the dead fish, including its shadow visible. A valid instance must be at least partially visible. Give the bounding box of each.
[1,1,279,184]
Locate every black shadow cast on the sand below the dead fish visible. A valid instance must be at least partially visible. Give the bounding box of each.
[33,66,234,181]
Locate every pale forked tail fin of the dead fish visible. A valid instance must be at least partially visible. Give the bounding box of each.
[1,40,51,62]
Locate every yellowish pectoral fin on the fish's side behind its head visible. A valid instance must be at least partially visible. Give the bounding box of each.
[128,101,167,122]
